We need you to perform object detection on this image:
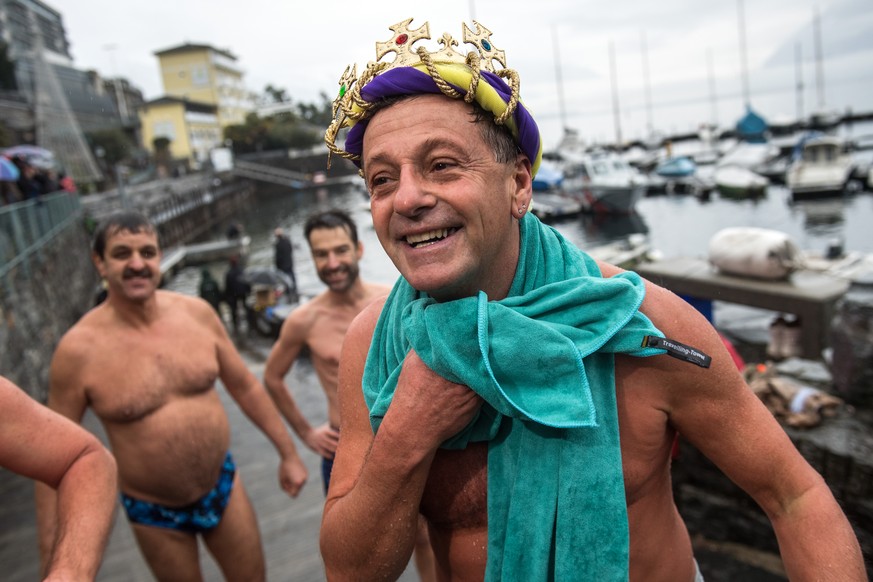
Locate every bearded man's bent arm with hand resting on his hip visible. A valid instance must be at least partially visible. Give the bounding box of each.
[264,305,339,459]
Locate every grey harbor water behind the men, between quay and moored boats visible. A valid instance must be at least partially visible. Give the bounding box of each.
[172,180,873,293]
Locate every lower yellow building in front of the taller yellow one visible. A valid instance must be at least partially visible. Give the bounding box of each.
[139,97,222,169]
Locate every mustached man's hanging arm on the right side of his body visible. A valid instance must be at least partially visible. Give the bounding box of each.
[209,302,308,497]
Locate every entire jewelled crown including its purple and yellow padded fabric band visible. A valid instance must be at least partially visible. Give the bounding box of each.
[324,18,543,175]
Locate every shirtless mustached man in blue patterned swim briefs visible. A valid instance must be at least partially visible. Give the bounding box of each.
[37,212,306,582]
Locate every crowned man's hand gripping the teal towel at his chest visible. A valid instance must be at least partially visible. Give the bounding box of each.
[388,350,483,449]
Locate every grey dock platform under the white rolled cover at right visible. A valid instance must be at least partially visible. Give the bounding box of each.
[634,257,850,359]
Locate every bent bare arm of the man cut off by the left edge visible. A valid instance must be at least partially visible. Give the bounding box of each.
[0,376,117,582]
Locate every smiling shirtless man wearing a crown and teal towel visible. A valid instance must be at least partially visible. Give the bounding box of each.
[321,21,866,582]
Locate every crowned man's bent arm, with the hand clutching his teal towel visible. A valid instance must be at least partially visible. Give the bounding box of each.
[321,302,481,580]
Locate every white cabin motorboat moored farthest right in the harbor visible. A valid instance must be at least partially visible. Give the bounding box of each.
[785,135,854,200]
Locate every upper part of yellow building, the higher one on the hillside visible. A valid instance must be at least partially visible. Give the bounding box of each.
[155,43,252,128]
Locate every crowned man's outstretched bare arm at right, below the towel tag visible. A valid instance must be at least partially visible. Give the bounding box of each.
[605,271,866,581]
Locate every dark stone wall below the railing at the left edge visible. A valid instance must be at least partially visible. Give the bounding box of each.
[0,220,99,401]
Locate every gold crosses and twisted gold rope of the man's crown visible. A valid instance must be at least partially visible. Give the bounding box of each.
[325,18,519,167]
